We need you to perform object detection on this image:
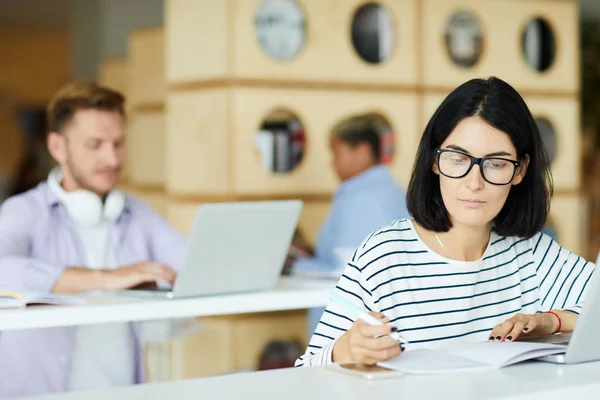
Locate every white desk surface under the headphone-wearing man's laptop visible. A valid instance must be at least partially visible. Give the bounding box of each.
[0,278,335,331]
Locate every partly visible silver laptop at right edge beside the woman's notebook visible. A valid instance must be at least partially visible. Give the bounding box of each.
[522,272,600,364]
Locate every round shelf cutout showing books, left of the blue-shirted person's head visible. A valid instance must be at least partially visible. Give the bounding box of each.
[254,109,306,174]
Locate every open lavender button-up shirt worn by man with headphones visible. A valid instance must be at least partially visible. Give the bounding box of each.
[0,182,187,398]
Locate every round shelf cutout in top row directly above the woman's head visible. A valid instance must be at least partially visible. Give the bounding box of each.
[444,11,483,68]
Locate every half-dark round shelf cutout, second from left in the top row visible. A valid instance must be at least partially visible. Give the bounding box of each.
[351,3,395,64]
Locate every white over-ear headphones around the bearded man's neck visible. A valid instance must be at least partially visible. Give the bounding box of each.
[48,167,125,227]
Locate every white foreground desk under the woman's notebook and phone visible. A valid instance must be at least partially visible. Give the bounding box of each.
[18,362,600,400]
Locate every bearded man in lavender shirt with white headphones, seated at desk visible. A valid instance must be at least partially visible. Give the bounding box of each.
[0,82,186,397]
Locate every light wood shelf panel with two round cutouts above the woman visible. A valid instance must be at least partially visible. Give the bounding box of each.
[421,0,579,94]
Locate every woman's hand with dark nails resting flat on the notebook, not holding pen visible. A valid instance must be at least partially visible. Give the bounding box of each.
[489,313,559,342]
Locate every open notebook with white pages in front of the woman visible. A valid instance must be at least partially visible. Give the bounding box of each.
[378,342,567,374]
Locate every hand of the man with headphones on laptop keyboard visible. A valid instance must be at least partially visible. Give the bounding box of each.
[102,262,177,290]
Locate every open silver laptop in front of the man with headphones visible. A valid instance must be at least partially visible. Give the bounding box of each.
[120,200,303,299]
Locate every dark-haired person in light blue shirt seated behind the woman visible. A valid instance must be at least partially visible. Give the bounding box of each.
[292,116,409,334]
